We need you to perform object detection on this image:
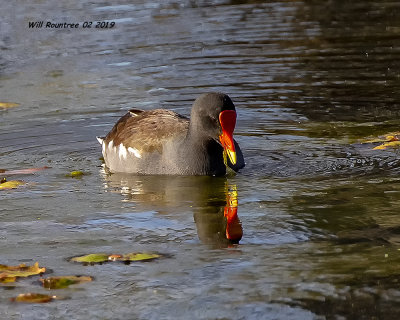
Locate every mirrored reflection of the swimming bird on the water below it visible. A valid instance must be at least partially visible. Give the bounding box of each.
[103,173,243,247]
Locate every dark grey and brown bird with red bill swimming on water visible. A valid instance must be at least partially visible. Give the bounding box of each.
[98,93,244,175]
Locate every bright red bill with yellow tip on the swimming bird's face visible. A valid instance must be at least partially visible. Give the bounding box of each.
[219,110,236,164]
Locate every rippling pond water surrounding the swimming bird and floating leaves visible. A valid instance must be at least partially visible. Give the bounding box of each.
[0,0,400,319]
